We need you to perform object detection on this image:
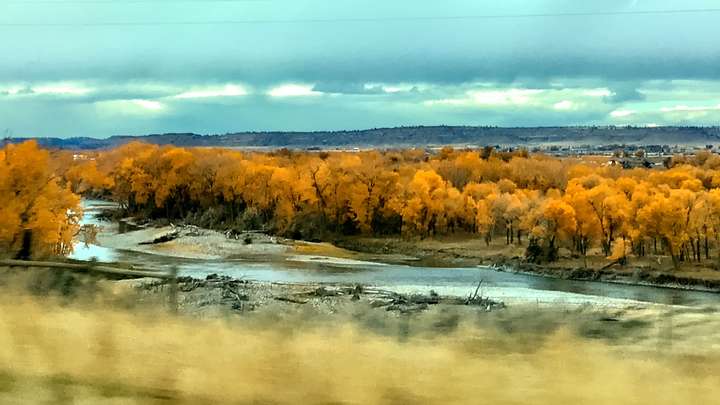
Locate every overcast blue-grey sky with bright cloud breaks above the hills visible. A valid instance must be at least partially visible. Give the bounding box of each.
[0,0,720,137]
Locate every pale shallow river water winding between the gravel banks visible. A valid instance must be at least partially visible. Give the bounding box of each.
[72,202,720,305]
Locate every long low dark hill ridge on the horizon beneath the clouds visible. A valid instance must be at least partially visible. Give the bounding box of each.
[11,126,720,149]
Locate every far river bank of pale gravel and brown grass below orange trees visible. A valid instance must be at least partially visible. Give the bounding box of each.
[75,202,720,292]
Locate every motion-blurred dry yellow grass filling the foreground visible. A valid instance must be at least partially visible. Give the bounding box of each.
[0,288,720,405]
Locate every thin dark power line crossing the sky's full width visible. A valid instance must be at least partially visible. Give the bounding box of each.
[0,7,720,27]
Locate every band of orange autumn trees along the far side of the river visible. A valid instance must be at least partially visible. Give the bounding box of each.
[0,142,720,267]
